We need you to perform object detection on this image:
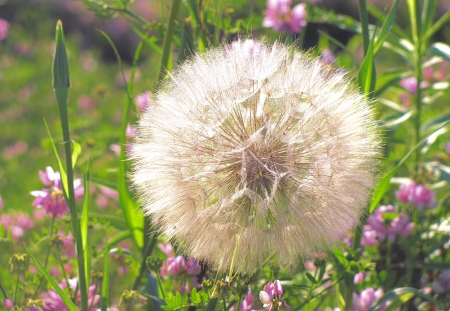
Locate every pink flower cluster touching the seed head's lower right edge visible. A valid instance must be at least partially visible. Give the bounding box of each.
[362,205,414,246]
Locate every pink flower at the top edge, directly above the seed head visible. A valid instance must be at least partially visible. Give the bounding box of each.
[263,0,306,33]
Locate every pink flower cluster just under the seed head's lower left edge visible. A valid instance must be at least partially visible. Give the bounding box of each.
[158,243,202,294]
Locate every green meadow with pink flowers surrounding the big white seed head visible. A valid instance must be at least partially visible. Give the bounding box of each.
[0,0,450,310]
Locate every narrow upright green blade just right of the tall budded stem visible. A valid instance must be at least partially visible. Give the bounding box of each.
[81,161,91,288]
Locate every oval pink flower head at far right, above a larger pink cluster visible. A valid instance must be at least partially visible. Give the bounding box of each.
[395,182,438,210]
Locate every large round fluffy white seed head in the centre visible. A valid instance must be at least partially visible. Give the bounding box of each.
[132,40,380,272]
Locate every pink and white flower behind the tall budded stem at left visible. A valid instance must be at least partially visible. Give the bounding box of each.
[30,166,84,217]
